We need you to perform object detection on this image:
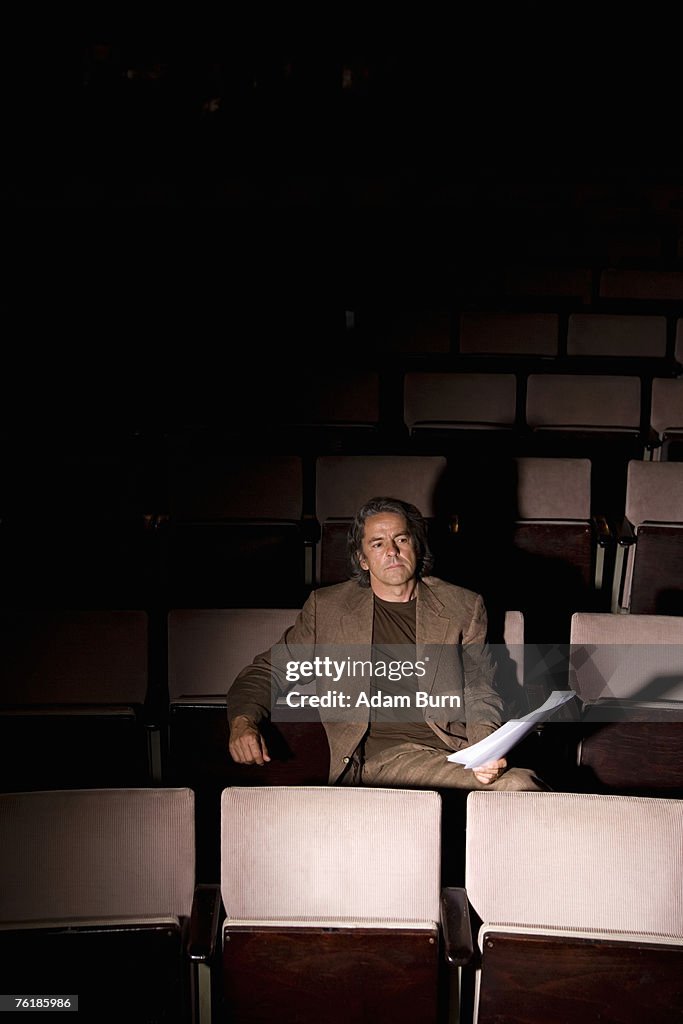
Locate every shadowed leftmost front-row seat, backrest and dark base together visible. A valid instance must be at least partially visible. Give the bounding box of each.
[0,788,210,1024]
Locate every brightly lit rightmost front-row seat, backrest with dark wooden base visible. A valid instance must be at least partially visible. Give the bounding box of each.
[454,792,683,1024]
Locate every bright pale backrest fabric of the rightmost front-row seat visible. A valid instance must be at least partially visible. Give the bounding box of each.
[465,792,683,940]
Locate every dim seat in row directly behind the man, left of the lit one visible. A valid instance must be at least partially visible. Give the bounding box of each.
[158,442,306,607]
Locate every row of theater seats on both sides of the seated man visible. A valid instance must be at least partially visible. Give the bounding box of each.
[0,608,683,882]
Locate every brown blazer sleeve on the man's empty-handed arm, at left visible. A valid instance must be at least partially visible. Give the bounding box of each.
[227,591,315,725]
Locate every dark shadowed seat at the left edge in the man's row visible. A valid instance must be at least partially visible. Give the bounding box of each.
[0,608,161,791]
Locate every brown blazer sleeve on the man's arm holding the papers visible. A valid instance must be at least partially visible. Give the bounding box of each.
[462,595,503,745]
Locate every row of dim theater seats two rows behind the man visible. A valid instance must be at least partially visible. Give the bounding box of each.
[214,357,683,468]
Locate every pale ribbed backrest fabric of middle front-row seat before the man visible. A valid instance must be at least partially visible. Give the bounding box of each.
[221,786,441,925]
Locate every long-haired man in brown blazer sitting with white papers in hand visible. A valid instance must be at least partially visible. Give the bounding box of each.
[227,498,548,790]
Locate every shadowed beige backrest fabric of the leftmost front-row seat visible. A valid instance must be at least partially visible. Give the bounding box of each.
[0,788,195,925]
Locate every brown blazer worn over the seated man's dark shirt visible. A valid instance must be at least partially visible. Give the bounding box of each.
[227,577,503,783]
